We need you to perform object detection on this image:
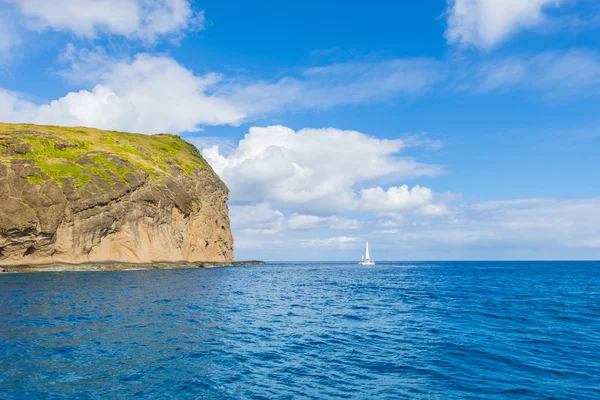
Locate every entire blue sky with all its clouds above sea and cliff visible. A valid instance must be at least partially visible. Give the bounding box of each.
[0,0,600,260]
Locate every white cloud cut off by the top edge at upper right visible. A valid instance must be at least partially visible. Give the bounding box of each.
[446,0,562,49]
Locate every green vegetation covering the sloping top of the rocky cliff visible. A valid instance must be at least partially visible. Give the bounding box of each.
[0,123,207,188]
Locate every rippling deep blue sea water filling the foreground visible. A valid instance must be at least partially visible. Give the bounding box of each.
[0,262,600,399]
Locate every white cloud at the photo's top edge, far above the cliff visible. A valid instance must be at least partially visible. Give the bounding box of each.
[4,0,204,42]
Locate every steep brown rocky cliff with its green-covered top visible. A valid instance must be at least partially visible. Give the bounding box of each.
[0,123,233,265]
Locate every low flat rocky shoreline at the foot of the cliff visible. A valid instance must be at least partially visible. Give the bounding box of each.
[0,260,265,274]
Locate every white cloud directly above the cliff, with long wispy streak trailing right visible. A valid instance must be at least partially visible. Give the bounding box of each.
[0,48,448,132]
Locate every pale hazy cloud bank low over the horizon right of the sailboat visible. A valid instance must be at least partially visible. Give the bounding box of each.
[372,198,600,259]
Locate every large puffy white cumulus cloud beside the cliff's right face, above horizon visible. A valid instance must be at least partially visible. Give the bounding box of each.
[201,126,448,259]
